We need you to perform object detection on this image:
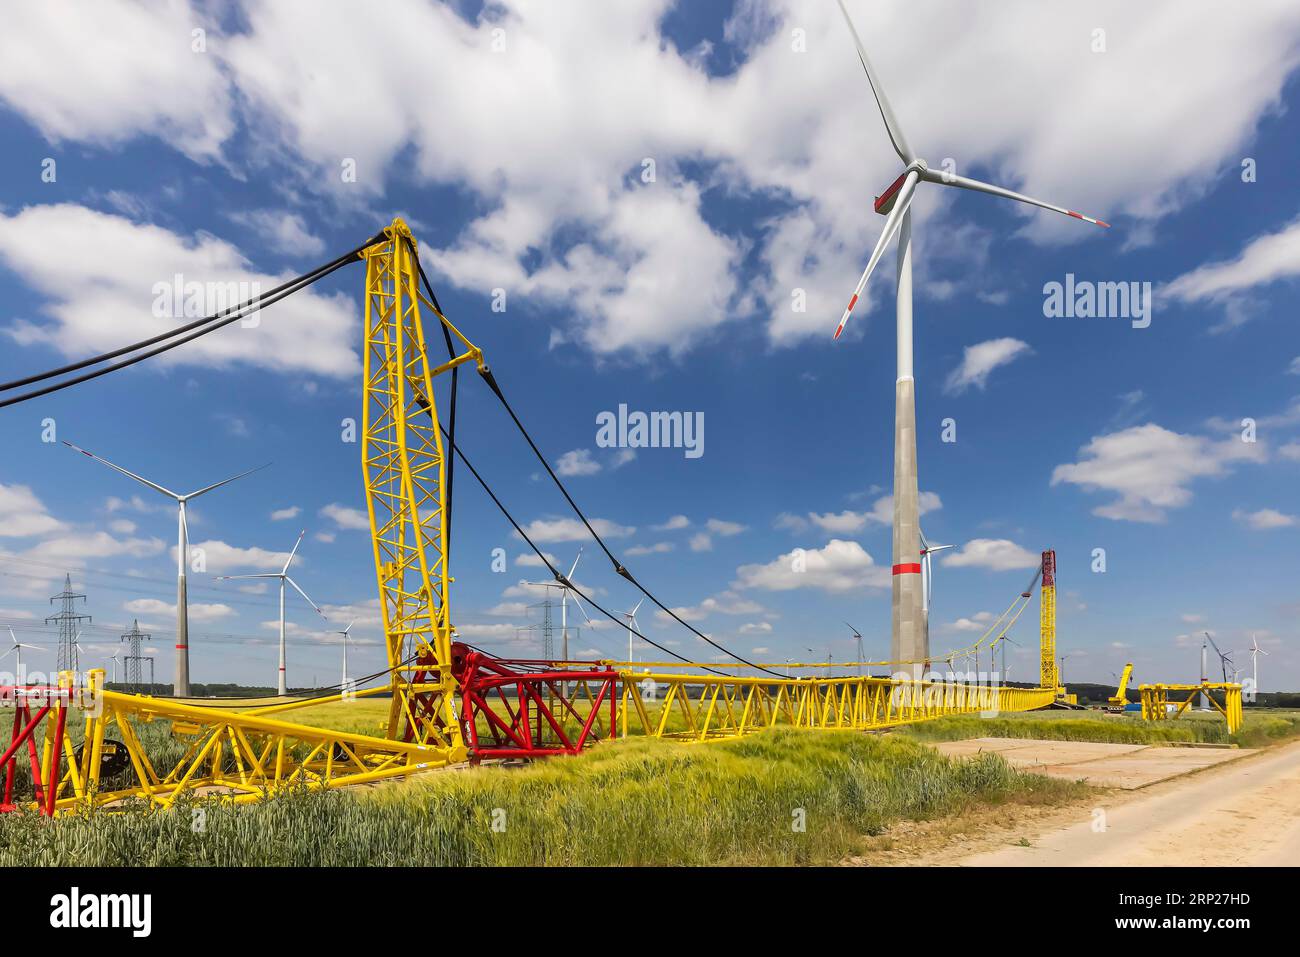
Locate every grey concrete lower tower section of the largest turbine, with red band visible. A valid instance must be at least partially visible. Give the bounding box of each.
[891,377,930,676]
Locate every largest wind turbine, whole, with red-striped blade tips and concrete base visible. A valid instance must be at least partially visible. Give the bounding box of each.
[835,0,1108,674]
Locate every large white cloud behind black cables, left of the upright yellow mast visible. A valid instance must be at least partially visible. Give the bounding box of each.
[0,203,360,377]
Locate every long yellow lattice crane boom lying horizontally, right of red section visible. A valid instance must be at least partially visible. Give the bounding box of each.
[620,671,1056,741]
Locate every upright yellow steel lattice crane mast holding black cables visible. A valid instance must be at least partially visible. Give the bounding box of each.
[361,220,482,761]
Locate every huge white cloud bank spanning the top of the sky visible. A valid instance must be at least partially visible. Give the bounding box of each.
[0,0,1300,352]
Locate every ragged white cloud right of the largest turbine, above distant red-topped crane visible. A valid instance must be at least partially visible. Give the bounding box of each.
[1052,424,1265,523]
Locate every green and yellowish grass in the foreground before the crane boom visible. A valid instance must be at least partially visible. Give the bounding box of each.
[0,729,1084,866]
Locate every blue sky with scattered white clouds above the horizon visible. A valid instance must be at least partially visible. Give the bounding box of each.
[0,0,1300,689]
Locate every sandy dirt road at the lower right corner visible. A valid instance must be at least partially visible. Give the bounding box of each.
[948,742,1300,867]
